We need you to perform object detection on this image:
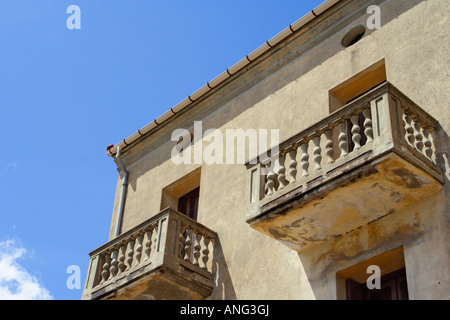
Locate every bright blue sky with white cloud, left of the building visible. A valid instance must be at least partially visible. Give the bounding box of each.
[0,0,324,300]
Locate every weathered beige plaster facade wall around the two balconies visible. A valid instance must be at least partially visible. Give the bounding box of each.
[104,0,450,299]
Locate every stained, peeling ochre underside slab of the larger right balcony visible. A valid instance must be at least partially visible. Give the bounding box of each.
[247,151,442,252]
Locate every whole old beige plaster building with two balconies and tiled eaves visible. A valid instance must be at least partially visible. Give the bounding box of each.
[83,0,450,299]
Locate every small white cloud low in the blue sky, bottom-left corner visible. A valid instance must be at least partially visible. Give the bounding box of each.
[0,240,53,300]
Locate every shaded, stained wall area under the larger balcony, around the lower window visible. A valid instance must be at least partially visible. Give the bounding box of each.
[299,194,449,299]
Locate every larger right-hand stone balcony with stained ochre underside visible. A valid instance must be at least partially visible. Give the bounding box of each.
[246,82,444,252]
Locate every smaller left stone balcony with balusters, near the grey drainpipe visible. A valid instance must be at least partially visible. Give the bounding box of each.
[83,208,217,300]
